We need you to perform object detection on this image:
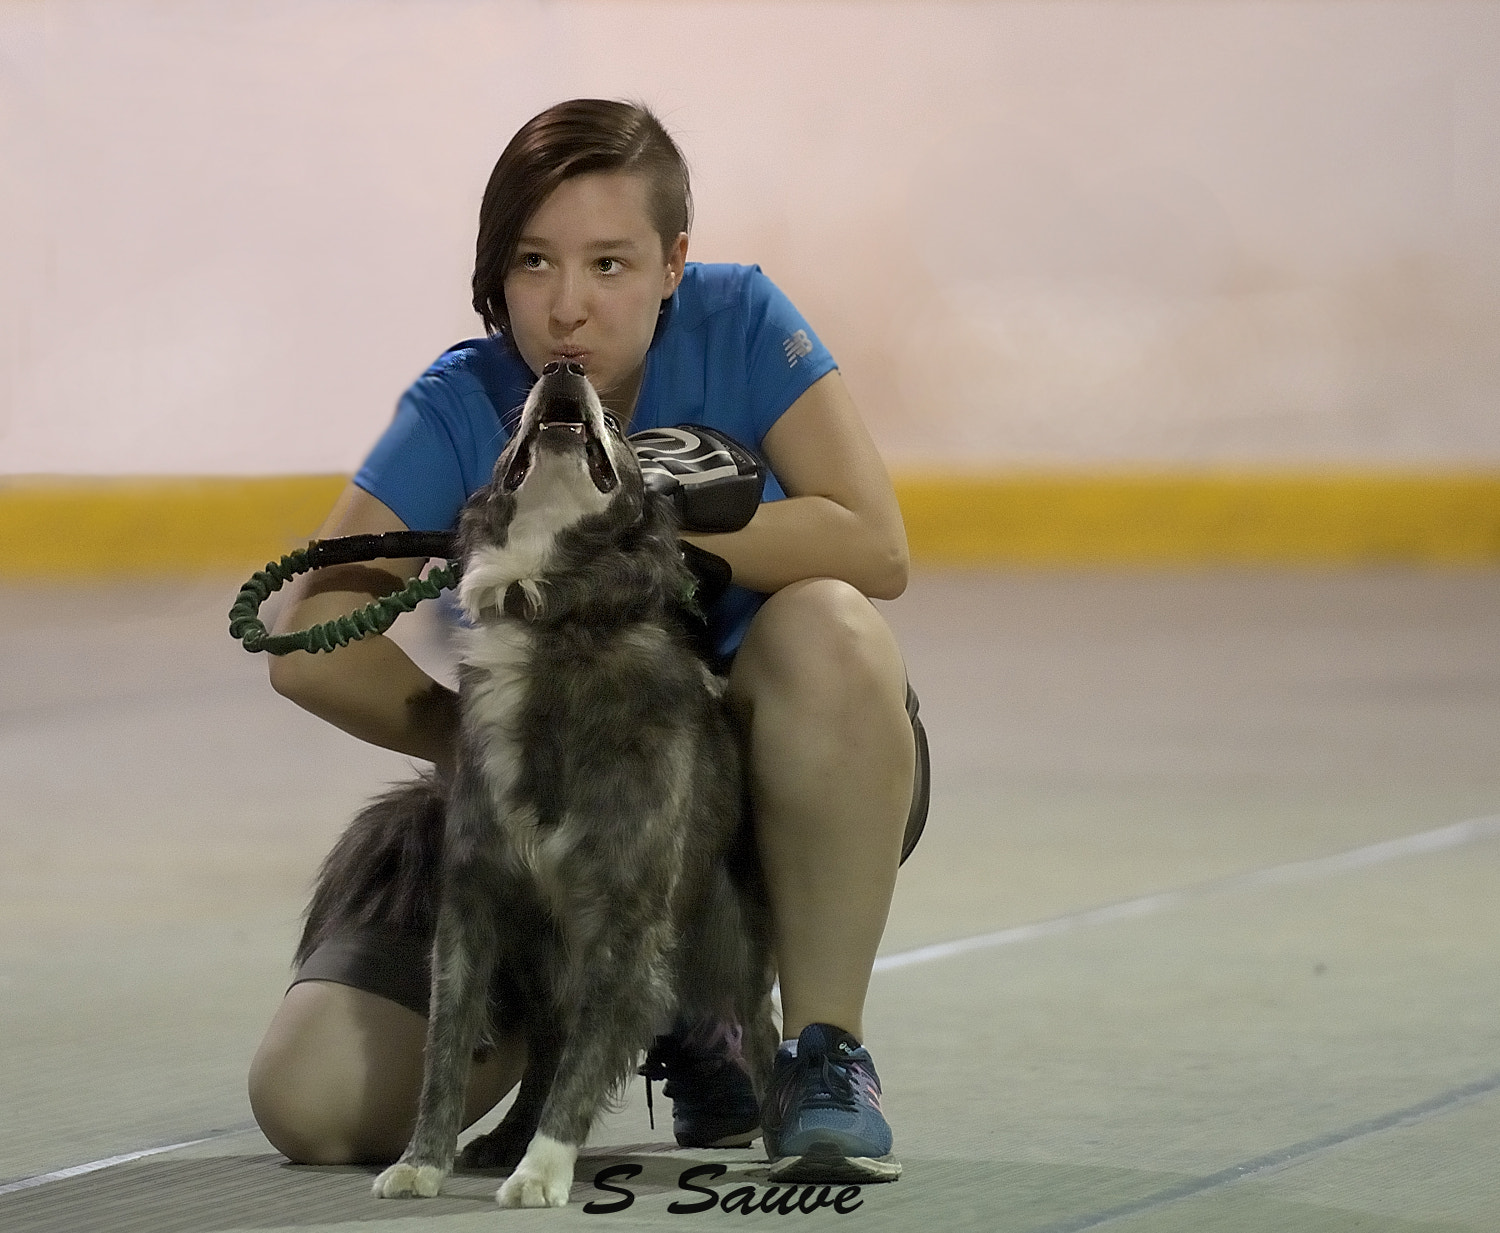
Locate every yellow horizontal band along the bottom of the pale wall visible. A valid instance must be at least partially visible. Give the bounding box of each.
[0,470,1500,579]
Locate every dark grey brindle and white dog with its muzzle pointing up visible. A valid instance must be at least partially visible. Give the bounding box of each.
[364,363,776,1208]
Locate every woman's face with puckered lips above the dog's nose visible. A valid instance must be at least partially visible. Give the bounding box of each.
[506,171,687,416]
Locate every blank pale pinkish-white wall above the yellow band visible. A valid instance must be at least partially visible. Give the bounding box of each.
[0,0,1500,473]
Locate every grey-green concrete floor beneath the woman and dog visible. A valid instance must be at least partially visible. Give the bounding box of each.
[0,572,1500,1233]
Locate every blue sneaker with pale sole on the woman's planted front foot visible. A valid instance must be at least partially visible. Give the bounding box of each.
[762,1023,902,1185]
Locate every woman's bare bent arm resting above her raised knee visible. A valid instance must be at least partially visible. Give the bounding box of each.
[684,371,908,600]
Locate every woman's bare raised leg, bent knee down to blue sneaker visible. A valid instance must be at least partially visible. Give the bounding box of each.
[729,579,915,1040]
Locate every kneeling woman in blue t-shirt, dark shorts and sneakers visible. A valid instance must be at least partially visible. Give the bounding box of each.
[251,99,926,1181]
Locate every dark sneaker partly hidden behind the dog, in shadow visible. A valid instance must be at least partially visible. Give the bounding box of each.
[641,1020,761,1148]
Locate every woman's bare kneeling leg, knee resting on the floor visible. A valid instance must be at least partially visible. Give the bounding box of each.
[249,981,525,1164]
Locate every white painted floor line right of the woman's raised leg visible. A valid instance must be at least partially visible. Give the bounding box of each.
[875,816,1500,972]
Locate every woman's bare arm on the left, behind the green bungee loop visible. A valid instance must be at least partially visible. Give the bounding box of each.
[270,485,458,773]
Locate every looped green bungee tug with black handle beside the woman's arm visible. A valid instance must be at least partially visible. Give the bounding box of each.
[230,531,464,656]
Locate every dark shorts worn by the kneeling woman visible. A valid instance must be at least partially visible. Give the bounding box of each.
[293,686,932,1017]
